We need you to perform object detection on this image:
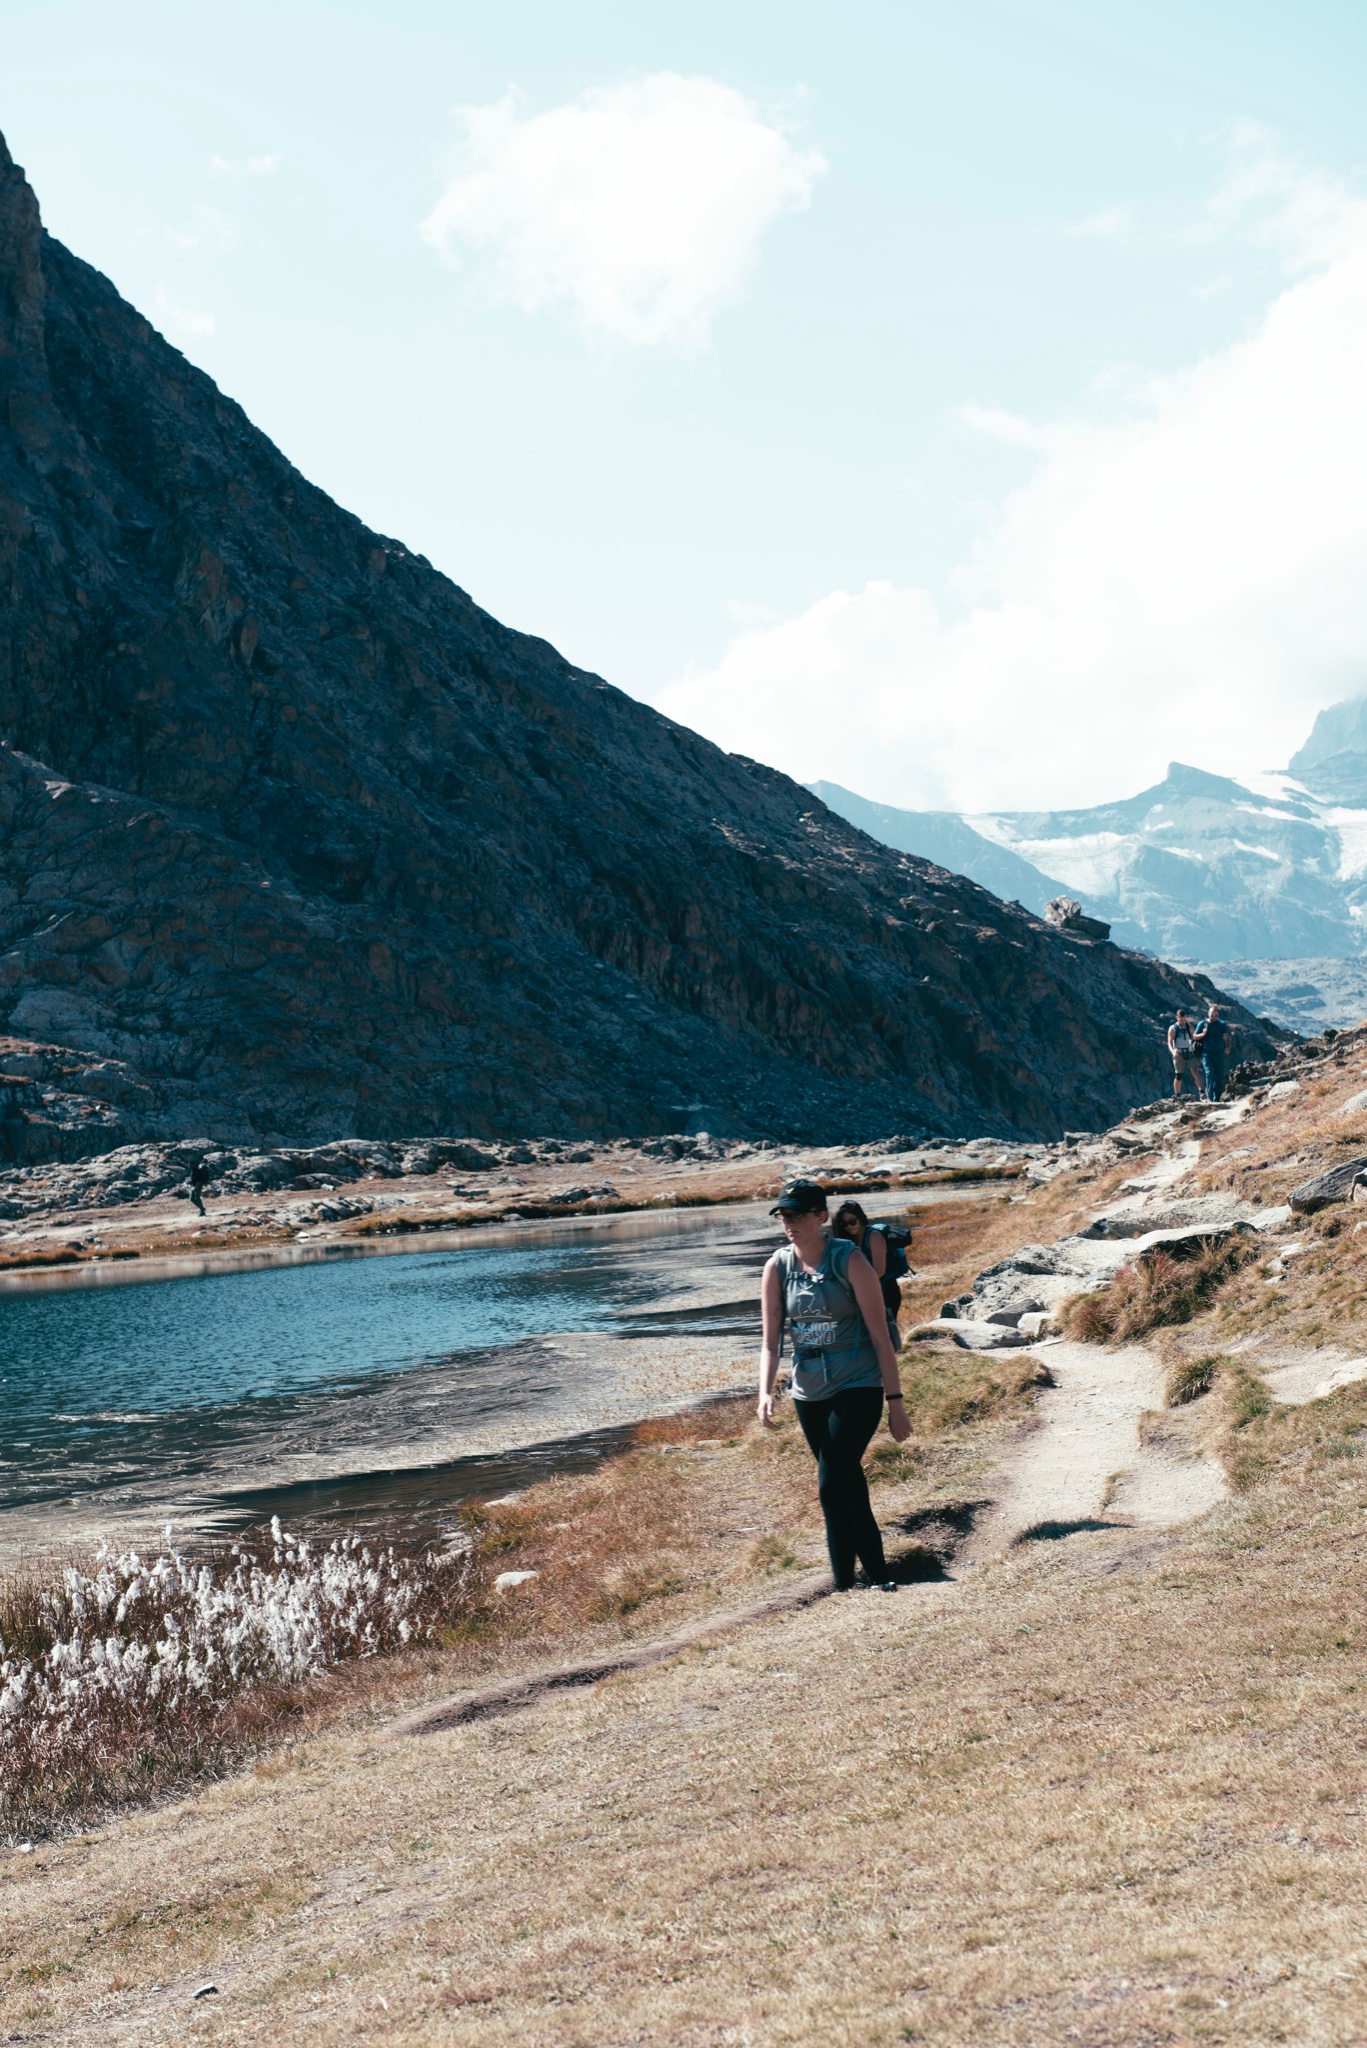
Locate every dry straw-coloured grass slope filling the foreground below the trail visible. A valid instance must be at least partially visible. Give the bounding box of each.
[0,1425,1367,2048]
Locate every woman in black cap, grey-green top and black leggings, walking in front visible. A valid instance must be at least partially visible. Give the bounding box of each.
[758,1180,912,1593]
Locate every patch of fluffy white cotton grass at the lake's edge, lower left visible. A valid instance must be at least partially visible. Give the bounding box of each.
[0,1518,469,1835]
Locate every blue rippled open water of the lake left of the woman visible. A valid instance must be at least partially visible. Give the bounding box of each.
[0,1210,775,1507]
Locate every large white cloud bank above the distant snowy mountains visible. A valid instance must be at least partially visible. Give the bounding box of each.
[656,136,1367,811]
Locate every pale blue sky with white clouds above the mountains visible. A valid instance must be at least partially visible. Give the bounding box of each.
[0,0,1367,809]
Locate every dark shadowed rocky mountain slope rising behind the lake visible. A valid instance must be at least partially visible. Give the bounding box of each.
[0,143,1267,1155]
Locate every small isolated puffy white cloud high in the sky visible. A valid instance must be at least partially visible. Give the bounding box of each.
[420,72,826,346]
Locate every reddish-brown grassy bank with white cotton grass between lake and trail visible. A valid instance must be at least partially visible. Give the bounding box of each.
[0,1354,1037,1843]
